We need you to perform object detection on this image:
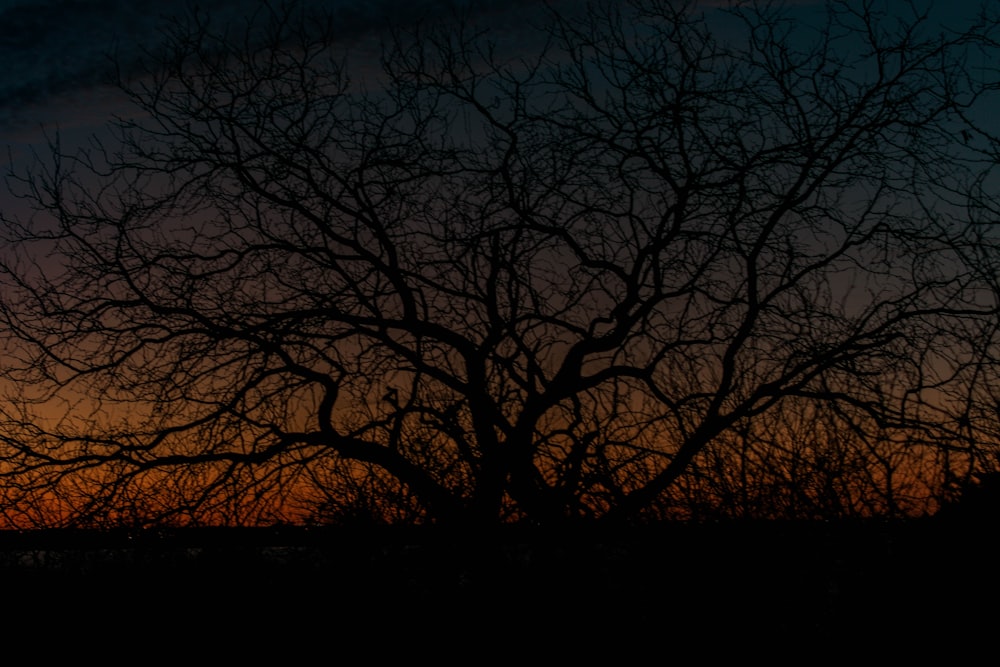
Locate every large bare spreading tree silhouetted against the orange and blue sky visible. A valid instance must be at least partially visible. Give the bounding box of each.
[2,0,1000,524]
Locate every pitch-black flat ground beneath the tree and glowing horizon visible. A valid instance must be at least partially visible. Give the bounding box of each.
[0,519,1000,665]
